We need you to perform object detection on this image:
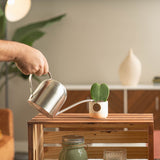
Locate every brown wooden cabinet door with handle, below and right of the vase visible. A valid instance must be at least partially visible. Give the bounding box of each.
[128,90,160,129]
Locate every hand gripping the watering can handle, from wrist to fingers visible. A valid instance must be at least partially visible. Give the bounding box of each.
[15,44,49,76]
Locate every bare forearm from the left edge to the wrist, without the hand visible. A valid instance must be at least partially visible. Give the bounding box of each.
[0,40,20,61]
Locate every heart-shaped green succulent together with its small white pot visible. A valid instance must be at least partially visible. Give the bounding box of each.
[89,83,110,118]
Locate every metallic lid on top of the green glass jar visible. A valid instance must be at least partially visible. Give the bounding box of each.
[62,135,84,144]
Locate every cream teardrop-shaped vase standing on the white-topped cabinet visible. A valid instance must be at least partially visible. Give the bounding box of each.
[119,49,142,86]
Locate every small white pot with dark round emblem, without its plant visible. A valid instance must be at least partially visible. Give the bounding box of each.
[89,101,108,118]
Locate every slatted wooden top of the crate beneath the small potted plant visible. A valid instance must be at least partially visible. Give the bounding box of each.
[28,113,153,123]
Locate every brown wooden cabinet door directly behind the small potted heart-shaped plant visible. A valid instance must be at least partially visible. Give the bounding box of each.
[62,90,123,113]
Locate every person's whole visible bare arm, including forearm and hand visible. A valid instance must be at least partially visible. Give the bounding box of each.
[0,40,48,76]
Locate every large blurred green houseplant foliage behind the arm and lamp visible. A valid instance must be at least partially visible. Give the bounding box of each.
[0,12,65,89]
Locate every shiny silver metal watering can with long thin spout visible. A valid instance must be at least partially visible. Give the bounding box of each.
[28,72,93,118]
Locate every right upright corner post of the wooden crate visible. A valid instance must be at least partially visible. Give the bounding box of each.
[148,124,154,160]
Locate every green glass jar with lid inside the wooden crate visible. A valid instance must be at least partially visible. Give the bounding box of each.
[59,135,88,160]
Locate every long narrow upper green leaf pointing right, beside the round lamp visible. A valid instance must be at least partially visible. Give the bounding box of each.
[12,14,65,42]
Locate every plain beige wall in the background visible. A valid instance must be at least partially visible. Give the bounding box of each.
[0,0,160,145]
